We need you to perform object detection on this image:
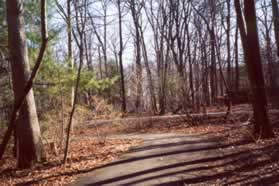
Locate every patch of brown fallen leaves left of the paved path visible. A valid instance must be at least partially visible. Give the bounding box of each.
[0,137,141,185]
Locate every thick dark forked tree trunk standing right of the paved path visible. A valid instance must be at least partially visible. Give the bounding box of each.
[235,0,273,138]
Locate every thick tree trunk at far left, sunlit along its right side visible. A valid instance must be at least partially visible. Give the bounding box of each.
[6,0,43,169]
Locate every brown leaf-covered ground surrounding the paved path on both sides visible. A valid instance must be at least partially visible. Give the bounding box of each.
[0,104,279,185]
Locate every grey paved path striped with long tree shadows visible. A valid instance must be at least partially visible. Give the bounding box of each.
[74,134,225,186]
